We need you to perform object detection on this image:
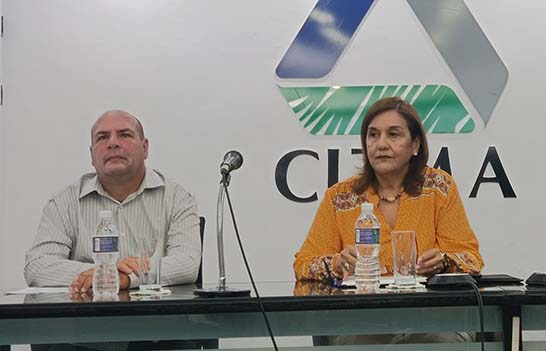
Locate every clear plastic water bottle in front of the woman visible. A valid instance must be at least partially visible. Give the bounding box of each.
[355,202,381,293]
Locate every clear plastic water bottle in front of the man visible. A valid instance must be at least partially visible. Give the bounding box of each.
[93,211,119,297]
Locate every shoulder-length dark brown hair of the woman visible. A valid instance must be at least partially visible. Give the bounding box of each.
[353,97,428,195]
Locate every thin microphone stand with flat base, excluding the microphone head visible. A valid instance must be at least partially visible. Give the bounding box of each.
[194,172,250,297]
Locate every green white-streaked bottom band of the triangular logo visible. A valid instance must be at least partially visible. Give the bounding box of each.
[279,85,474,135]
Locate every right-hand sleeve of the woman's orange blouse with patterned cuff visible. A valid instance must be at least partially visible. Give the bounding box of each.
[436,179,483,273]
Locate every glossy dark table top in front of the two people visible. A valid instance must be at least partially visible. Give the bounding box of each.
[0,282,546,319]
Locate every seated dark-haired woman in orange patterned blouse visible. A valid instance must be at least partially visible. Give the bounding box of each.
[294,97,483,280]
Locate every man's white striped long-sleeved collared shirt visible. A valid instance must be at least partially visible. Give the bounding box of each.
[25,170,201,287]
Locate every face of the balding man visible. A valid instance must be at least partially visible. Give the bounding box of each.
[91,113,148,177]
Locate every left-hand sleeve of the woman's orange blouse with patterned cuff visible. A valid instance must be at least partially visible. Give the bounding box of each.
[294,191,342,280]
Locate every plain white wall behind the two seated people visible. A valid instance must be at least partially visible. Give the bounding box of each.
[0,0,546,289]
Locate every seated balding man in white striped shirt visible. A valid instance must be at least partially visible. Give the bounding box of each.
[25,110,201,293]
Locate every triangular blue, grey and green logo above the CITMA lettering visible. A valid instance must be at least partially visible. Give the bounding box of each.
[276,0,508,135]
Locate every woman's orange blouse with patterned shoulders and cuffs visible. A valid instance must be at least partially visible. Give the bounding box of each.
[294,167,483,280]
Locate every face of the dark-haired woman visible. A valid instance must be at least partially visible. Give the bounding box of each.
[366,110,420,177]
